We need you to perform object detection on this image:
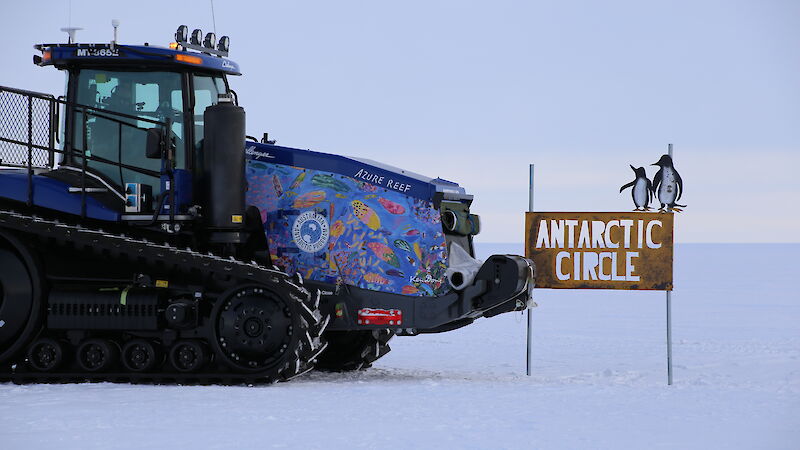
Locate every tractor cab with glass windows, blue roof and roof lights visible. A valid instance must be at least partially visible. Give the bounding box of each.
[14,26,241,221]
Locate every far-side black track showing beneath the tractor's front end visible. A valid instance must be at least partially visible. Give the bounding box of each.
[317,330,394,372]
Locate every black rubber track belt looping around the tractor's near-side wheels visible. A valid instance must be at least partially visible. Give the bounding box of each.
[0,210,329,384]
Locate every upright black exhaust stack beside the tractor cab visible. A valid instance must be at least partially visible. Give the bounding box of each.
[200,96,248,244]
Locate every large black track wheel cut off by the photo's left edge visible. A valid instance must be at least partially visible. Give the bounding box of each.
[0,232,42,364]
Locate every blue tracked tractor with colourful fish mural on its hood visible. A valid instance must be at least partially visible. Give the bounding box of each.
[0,26,534,384]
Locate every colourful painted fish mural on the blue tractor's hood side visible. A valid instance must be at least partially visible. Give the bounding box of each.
[246,160,449,296]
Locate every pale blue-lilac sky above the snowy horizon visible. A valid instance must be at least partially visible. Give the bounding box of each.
[0,0,800,242]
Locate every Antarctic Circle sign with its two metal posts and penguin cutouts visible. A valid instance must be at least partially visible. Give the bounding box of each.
[525,144,685,386]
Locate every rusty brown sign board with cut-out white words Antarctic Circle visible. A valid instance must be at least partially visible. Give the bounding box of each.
[525,212,674,291]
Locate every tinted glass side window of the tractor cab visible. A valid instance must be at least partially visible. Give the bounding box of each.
[74,69,186,194]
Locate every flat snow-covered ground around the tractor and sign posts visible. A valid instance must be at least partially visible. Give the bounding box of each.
[0,244,800,449]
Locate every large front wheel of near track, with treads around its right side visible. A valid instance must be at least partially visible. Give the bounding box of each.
[212,282,328,382]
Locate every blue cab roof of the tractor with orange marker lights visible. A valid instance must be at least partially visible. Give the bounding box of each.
[34,43,241,75]
